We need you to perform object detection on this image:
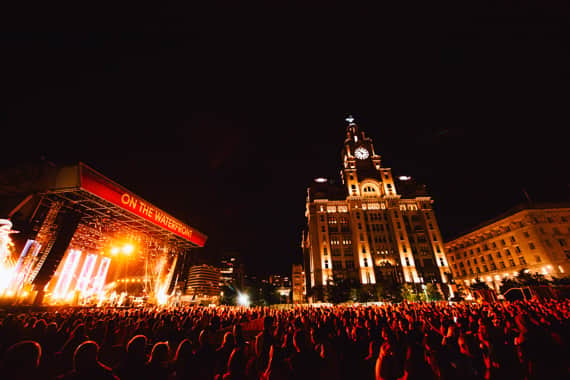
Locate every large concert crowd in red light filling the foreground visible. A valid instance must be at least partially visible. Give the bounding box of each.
[0,300,570,380]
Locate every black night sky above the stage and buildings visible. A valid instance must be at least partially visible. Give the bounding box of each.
[0,1,570,274]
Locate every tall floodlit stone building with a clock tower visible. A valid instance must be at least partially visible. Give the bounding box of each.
[302,117,449,300]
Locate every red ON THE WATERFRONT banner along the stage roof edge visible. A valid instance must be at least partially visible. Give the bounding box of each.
[80,165,206,247]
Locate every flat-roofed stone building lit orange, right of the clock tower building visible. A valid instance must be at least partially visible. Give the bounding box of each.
[445,204,570,291]
